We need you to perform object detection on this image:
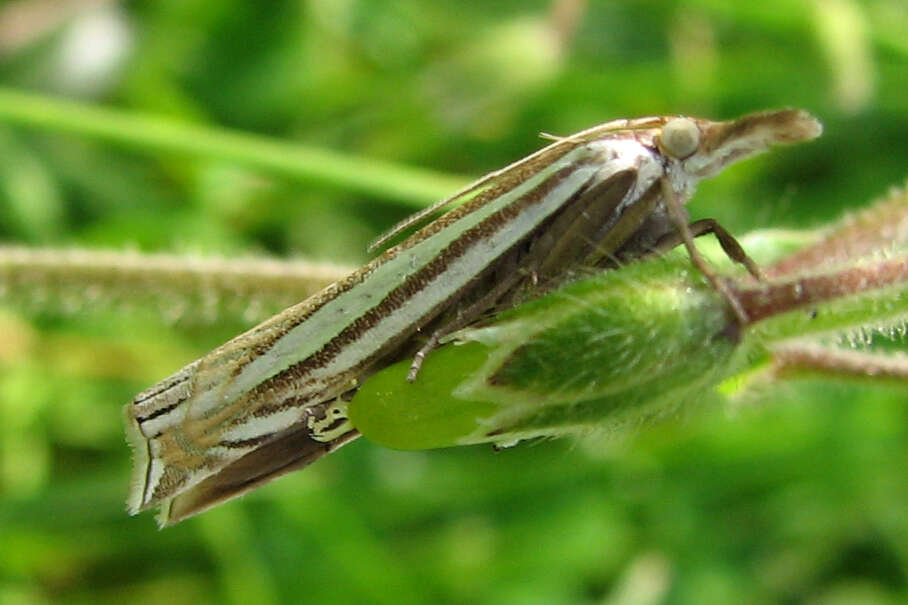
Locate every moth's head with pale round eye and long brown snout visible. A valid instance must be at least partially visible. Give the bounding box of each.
[672,109,823,178]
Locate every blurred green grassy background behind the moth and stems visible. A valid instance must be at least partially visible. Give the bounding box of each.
[0,0,908,605]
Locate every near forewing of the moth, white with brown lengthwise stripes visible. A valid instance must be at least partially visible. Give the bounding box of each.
[128,144,626,511]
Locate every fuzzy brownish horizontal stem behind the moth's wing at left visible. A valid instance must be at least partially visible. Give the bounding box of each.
[0,246,350,323]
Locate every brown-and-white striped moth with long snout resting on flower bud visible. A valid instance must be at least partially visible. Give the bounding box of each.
[125,109,822,526]
